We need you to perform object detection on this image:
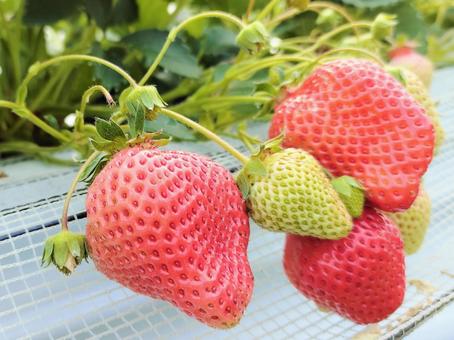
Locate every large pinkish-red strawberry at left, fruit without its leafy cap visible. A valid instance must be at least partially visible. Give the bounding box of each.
[86,147,253,328]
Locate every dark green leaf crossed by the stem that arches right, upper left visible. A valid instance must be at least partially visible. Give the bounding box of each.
[123,29,202,78]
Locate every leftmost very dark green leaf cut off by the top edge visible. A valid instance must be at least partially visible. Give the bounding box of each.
[23,0,83,25]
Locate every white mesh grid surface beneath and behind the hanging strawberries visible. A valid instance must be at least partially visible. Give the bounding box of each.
[0,71,454,339]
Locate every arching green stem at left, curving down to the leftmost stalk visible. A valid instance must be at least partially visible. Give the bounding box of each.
[16,54,137,104]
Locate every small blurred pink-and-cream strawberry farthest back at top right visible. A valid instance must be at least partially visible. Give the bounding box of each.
[389,44,434,88]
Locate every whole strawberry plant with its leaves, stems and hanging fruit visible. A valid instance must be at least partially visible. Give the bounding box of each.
[0,0,443,328]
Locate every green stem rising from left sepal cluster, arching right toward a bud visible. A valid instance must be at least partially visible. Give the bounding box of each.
[139,11,245,85]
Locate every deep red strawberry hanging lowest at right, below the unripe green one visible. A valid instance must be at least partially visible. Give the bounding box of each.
[284,208,405,324]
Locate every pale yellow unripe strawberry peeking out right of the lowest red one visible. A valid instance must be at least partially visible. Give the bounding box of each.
[387,186,431,255]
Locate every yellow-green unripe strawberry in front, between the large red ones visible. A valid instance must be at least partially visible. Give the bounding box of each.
[239,148,352,239]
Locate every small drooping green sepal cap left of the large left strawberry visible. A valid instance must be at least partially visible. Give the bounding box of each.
[41,231,88,275]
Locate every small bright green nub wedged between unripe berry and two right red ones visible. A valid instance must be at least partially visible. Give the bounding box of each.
[331,176,365,218]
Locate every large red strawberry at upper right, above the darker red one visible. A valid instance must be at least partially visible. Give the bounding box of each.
[269,59,434,211]
